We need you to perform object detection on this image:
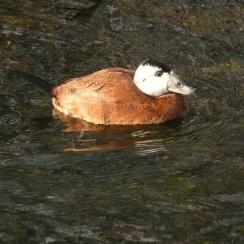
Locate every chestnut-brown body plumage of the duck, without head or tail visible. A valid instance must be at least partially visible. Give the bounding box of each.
[52,68,185,125]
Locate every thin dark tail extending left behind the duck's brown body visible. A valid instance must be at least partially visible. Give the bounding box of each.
[8,70,54,95]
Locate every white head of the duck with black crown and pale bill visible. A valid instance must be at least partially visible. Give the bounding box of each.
[134,59,195,97]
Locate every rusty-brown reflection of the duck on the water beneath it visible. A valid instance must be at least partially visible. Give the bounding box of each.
[55,112,181,155]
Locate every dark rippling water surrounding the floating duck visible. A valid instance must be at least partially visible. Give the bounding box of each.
[0,0,244,243]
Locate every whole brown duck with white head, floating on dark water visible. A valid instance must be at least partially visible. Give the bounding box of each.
[51,59,195,125]
